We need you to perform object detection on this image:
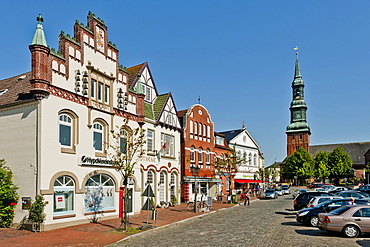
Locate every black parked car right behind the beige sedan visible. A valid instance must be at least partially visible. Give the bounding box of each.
[296,198,370,226]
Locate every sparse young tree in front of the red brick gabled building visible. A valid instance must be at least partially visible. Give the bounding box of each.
[213,148,245,203]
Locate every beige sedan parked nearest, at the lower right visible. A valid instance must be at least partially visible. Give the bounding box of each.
[317,205,370,238]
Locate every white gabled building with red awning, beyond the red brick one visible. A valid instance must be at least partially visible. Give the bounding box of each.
[219,125,265,190]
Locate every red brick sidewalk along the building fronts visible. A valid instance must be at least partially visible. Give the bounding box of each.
[0,198,255,247]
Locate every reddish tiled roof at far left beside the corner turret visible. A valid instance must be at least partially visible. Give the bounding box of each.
[0,72,34,106]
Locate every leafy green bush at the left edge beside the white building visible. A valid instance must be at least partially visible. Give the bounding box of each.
[0,159,19,227]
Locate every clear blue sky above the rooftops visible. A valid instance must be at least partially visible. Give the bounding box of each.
[0,0,370,165]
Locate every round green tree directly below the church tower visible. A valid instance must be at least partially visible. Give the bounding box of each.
[282,147,313,182]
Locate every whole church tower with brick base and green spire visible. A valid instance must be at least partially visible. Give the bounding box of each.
[285,52,311,156]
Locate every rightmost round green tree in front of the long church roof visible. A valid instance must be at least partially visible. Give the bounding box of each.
[328,147,353,183]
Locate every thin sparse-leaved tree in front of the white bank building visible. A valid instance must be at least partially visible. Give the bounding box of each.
[109,116,145,231]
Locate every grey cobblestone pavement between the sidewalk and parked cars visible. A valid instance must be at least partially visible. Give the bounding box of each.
[110,195,370,247]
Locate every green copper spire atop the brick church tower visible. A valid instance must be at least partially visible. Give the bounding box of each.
[286,52,311,134]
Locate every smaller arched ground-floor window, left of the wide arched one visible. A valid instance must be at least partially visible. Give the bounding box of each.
[53,176,75,216]
